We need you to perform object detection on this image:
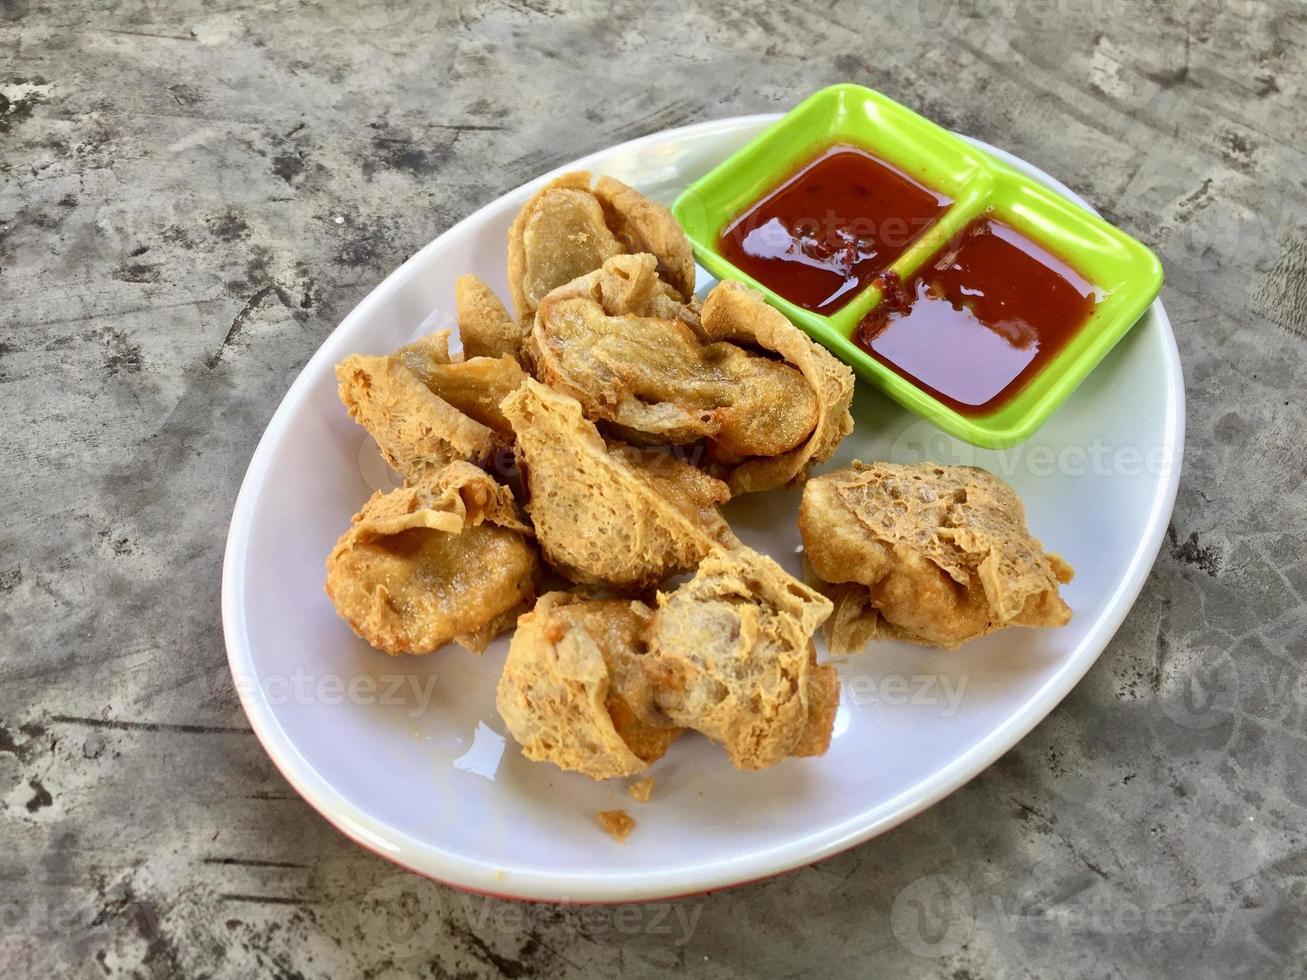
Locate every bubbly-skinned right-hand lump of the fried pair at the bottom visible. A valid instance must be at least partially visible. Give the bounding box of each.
[642,547,839,770]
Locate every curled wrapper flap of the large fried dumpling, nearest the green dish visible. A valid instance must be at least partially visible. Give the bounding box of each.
[702,280,853,494]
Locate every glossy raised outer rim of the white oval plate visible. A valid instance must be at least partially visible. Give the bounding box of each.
[222,112,1185,903]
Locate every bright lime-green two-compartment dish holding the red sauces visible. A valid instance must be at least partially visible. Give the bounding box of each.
[672,85,1162,448]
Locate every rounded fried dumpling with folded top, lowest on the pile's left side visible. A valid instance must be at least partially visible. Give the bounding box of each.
[327,461,538,653]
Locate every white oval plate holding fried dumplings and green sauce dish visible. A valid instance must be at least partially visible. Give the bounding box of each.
[222,115,1184,902]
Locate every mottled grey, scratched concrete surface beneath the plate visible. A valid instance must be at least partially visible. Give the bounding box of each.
[0,0,1307,980]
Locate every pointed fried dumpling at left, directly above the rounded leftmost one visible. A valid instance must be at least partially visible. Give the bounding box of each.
[336,331,525,481]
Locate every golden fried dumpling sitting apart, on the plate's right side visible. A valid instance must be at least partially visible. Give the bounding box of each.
[799,461,1074,652]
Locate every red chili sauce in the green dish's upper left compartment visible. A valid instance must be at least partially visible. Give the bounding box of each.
[718,145,953,314]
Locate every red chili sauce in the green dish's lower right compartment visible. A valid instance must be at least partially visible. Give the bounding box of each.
[853,218,1098,416]
